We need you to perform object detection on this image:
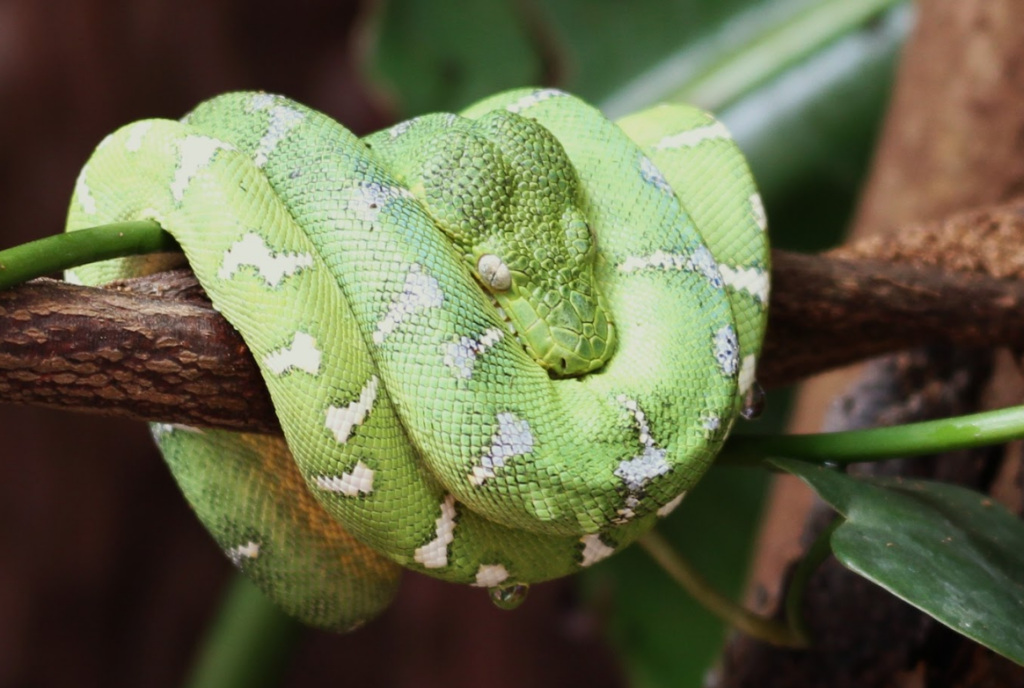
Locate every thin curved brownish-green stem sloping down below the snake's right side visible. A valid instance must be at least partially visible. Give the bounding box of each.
[637,530,806,647]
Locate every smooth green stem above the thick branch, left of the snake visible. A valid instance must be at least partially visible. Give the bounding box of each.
[0,220,181,289]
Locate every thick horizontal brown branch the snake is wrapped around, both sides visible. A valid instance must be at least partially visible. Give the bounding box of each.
[0,200,1024,433]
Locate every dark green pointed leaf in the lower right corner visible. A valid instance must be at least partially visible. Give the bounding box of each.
[771,459,1024,664]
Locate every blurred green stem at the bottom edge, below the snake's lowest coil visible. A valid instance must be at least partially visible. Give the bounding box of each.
[185,574,302,688]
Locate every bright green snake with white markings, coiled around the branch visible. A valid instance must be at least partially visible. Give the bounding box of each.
[67,89,769,630]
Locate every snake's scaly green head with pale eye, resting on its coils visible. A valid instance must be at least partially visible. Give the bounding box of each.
[406,111,615,377]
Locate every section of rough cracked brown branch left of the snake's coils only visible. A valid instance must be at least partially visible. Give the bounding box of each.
[0,275,276,430]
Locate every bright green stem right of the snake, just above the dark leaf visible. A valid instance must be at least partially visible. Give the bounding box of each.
[719,406,1024,466]
